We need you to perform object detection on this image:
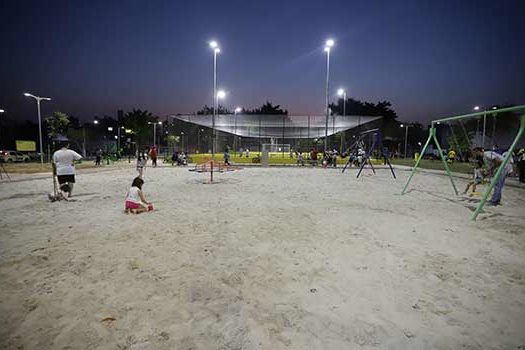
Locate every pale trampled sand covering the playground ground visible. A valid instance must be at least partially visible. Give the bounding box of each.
[0,167,525,350]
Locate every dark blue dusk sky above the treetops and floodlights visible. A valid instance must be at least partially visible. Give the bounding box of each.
[0,0,525,122]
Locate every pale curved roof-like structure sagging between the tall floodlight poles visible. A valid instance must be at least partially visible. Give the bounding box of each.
[173,114,381,138]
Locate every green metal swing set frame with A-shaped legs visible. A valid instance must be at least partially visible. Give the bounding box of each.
[401,105,525,221]
